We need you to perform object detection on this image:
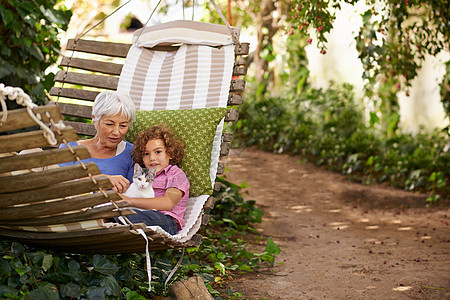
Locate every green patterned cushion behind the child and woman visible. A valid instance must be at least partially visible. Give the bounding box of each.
[125,107,227,197]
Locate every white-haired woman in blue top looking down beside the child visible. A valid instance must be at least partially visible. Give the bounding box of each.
[60,91,136,193]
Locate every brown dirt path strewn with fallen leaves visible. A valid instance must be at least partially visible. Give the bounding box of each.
[221,149,450,300]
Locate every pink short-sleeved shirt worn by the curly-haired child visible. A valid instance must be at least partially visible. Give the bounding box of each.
[153,165,190,230]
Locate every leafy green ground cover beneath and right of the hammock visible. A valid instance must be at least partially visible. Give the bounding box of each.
[0,178,280,300]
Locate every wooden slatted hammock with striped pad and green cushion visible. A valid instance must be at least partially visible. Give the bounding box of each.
[0,1,249,254]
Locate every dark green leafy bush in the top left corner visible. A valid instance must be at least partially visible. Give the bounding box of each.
[0,0,72,104]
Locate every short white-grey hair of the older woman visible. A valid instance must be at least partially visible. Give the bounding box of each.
[92,91,136,122]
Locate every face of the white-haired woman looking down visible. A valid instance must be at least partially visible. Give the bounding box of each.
[95,114,130,148]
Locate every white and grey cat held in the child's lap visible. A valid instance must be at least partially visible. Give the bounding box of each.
[123,164,156,198]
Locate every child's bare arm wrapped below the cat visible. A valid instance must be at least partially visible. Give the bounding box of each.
[120,187,183,211]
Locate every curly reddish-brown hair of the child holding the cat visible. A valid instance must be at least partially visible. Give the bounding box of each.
[132,124,185,167]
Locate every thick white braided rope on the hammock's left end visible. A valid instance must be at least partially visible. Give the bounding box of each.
[0,83,64,146]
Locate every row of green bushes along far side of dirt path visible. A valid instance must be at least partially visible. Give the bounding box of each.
[234,84,450,203]
